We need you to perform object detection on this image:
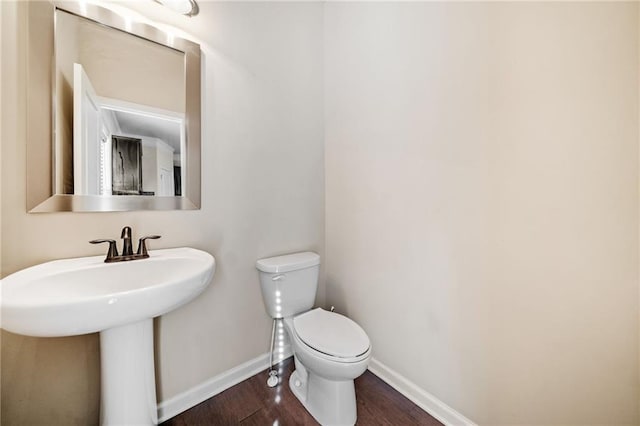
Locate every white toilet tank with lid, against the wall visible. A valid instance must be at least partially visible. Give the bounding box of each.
[256,251,320,318]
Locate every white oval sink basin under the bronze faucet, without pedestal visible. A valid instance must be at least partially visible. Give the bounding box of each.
[0,247,215,337]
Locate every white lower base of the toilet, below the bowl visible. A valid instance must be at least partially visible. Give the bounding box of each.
[289,363,357,426]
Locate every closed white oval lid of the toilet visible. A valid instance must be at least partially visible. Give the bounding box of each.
[293,308,370,358]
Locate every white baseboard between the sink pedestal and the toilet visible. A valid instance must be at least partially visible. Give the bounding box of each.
[158,345,293,423]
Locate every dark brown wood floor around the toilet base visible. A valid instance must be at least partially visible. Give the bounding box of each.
[162,358,441,426]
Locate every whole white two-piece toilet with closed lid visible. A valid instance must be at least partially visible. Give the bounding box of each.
[256,252,371,426]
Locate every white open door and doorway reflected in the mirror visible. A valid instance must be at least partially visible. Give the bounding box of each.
[73,63,185,197]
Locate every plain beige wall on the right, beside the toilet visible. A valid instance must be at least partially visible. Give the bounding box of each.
[324,2,640,425]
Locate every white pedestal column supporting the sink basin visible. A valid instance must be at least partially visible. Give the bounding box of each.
[100,318,158,426]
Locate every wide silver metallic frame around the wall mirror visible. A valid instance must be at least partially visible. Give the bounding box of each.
[26,1,201,213]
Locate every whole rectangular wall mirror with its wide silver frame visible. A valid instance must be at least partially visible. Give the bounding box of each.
[27,2,201,212]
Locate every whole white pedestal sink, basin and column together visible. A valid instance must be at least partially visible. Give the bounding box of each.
[0,247,215,425]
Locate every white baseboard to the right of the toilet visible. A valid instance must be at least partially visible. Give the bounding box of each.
[369,358,476,426]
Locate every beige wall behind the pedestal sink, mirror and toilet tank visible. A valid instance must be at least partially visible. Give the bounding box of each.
[0,2,324,425]
